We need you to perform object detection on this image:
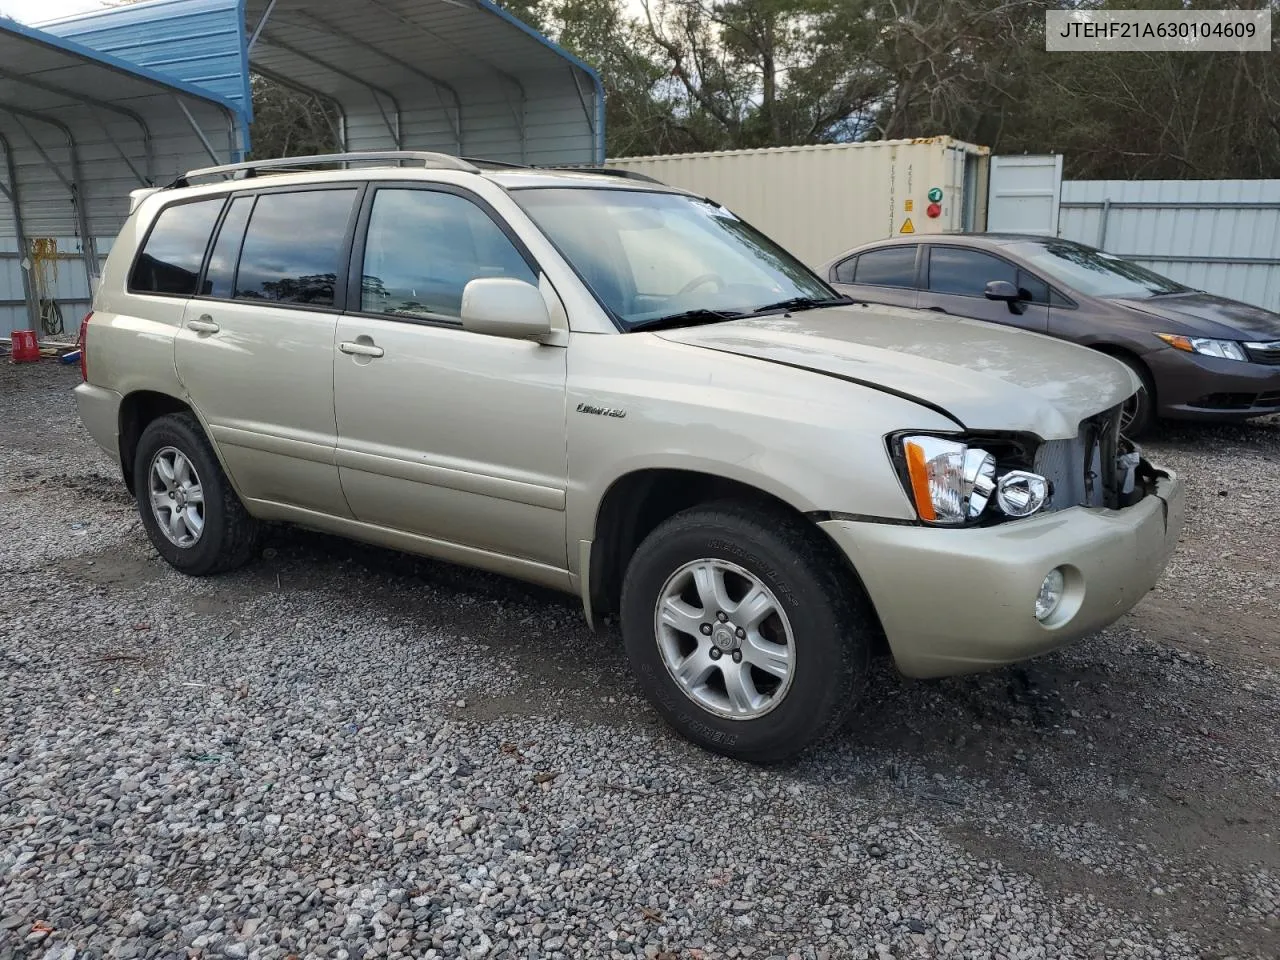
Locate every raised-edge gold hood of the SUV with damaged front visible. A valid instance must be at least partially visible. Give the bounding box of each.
[655,305,1139,440]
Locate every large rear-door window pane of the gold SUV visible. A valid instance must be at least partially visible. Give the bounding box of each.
[236,189,356,307]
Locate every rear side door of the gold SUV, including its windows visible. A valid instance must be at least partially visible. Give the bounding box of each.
[177,184,361,517]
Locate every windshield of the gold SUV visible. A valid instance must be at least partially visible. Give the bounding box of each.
[512,187,844,329]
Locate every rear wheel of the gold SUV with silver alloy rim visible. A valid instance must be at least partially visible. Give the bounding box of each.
[133,413,260,576]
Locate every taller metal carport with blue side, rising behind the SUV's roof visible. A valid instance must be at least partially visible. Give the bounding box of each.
[41,0,604,165]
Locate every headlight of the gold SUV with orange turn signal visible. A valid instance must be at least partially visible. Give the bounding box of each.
[900,436,1050,526]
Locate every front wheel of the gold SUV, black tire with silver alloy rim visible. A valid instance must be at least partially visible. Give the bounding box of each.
[621,503,876,762]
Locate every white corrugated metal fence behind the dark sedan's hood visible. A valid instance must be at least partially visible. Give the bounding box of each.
[1059,180,1280,311]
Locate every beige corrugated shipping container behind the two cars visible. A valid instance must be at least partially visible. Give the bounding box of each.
[608,137,989,266]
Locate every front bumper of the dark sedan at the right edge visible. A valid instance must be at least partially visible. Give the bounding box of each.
[1143,348,1280,420]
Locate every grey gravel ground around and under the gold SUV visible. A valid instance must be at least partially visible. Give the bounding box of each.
[0,364,1280,960]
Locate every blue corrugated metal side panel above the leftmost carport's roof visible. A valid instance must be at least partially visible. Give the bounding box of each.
[38,0,253,124]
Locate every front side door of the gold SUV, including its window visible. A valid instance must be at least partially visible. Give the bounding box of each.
[333,186,567,570]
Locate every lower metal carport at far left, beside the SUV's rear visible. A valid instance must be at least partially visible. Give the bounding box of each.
[0,19,244,335]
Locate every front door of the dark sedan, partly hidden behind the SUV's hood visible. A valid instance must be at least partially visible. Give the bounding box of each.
[916,243,1048,333]
